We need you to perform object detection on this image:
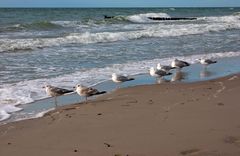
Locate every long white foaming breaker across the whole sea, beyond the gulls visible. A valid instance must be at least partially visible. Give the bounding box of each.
[0,17,240,52]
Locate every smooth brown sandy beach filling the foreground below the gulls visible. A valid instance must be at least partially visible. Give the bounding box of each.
[0,75,240,156]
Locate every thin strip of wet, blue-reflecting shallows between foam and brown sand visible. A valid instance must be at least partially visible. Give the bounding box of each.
[0,57,240,125]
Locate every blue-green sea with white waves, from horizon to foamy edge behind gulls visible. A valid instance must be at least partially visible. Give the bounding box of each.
[0,8,240,121]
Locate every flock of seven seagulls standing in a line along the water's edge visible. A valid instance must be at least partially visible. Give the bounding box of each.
[43,58,217,107]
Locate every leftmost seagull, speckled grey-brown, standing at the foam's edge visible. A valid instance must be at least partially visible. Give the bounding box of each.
[43,85,73,107]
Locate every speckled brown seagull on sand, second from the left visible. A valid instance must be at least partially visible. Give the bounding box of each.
[74,84,106,102]
